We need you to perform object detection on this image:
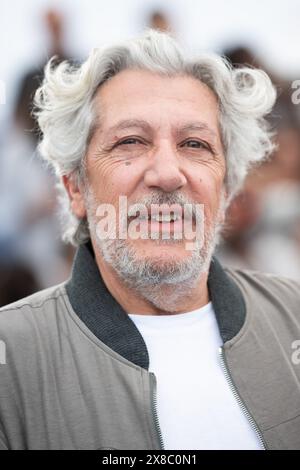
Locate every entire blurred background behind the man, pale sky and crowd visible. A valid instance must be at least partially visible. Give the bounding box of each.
[0,0,300,306]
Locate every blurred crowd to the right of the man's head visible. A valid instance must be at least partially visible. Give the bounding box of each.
[218,47,300,280]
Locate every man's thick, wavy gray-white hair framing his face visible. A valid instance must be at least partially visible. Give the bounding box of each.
[34,30,276,246]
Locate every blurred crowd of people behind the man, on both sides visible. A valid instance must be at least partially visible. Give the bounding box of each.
[0,10,300,306]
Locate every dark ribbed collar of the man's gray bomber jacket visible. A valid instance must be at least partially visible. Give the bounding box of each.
[66,243,246,369]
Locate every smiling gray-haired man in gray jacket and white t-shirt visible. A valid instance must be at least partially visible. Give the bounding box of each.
[0,31,300,449]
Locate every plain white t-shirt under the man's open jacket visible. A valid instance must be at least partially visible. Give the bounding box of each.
[129,302,261,450]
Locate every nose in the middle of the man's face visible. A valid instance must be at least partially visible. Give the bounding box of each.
[144,142,187,192]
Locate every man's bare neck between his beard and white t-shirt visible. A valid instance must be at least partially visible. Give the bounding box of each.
[93,241,209,315]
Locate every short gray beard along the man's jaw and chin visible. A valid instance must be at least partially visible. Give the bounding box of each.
[87,187,221,312]
